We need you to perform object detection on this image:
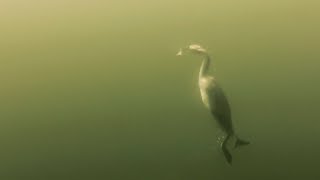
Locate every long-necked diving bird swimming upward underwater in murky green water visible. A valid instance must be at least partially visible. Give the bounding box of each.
[177,44,249,164]
